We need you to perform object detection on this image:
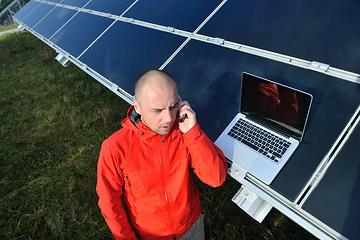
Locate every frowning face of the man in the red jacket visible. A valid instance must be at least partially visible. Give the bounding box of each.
[134,82,179,135]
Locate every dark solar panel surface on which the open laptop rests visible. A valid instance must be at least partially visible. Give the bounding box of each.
[165,40,360,200]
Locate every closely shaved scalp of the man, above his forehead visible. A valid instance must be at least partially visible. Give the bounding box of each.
[135,70,177,102]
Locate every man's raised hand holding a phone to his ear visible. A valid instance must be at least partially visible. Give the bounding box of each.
[179,96,196,133]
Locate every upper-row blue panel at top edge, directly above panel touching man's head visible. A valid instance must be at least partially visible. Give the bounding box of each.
[124,0,221,32]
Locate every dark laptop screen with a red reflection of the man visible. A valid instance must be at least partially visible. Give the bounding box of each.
[240,73,312,140]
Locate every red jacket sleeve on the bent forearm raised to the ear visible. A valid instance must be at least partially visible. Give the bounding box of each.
[183,123,227,187]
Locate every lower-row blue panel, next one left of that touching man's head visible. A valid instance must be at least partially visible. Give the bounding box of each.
[51,12,114,57]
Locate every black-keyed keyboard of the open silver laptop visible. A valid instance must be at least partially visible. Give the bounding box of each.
[228,118,291,163]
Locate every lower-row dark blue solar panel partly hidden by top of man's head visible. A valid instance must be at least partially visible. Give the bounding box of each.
[79,22,185,95]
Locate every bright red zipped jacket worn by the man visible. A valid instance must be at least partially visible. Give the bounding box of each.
[96,107,227,239]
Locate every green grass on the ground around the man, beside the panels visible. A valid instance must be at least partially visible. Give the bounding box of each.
[0,33,314,240]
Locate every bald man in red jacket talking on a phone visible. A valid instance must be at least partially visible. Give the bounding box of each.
[96,70,227,239]
